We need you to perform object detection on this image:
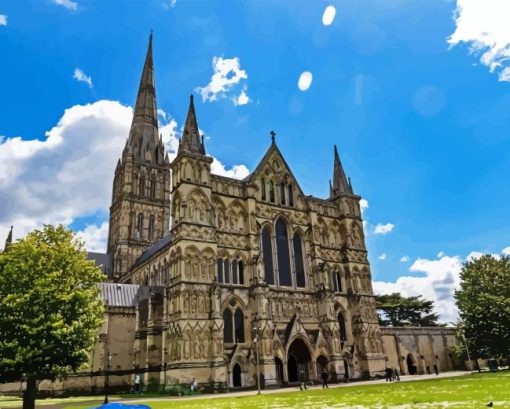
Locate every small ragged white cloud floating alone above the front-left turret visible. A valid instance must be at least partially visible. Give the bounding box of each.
[195,57,250,105]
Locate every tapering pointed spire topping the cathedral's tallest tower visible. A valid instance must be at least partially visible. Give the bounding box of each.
[128,32,159,159]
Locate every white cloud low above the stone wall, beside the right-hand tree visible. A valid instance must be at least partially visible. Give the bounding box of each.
[373,248,510,322]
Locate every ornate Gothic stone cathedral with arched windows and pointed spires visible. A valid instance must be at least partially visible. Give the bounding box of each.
[101,33,385,387]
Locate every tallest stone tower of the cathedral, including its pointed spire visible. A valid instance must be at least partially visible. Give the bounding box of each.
[108,34,170,281]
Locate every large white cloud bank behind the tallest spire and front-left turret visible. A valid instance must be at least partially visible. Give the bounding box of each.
[0,100,249,249]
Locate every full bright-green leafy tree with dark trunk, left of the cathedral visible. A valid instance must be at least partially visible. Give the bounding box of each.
[0,225,104,409]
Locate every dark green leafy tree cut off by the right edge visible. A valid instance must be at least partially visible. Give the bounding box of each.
[455,255,510,358]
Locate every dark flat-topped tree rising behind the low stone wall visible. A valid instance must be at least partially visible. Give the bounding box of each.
[375,293,439,327]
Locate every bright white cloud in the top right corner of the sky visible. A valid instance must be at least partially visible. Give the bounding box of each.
[448,0,510,81]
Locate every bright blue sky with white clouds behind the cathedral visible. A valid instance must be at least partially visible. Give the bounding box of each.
[0,0,510,320]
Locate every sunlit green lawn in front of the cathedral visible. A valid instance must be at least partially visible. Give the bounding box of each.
[0,371,510,409]
